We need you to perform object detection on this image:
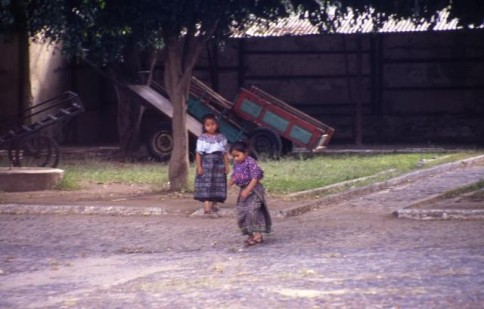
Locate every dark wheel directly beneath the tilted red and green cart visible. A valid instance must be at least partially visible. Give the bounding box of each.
[250,128,282,159]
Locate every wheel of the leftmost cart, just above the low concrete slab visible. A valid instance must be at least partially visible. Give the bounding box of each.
[15,134,59,167]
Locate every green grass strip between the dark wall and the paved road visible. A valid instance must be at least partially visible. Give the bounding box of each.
[54,152,483,194]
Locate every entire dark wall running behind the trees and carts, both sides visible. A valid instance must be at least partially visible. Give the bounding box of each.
[0,30,484,145]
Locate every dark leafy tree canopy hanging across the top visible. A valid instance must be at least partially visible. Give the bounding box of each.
[0,0,484,64]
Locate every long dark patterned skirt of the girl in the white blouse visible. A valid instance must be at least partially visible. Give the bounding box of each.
[194,152,227,203]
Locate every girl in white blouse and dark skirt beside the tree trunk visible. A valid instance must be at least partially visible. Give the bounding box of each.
[194,114,229,215]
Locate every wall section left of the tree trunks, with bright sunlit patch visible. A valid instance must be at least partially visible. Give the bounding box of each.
[0,37,117,144]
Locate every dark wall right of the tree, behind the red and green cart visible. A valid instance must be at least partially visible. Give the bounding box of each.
[187,30,484,144]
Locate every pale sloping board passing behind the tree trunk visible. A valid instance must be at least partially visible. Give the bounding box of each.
[128,85,202,137]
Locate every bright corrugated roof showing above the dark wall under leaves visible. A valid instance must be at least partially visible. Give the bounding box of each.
[234,12,460,37]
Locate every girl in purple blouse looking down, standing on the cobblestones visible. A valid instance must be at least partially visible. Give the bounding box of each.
[229,142,272,246]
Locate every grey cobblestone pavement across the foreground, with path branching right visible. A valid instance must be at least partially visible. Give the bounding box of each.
[0,162,484,308]
